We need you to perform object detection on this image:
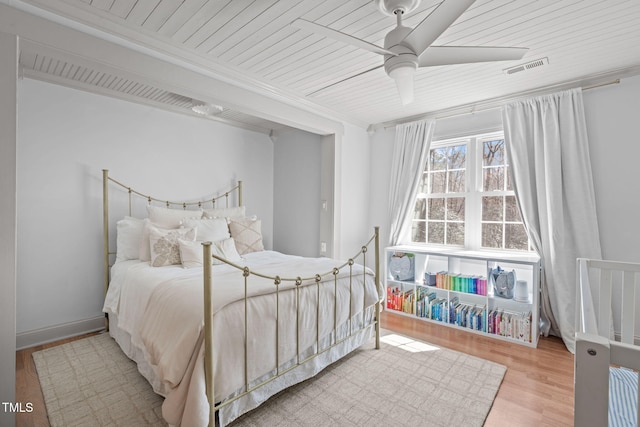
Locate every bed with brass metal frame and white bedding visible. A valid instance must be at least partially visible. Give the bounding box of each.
[104,171,382,426]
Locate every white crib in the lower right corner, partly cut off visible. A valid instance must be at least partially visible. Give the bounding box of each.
[574,259,640,427]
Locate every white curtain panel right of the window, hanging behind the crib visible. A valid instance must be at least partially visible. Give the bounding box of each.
[502,89,601,352]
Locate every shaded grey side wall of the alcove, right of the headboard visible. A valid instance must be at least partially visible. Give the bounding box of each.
[273,130,322,256]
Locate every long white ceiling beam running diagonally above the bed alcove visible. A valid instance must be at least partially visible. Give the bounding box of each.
[0,3,343,135]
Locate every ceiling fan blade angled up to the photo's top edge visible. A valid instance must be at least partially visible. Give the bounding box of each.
[400,0,475,56]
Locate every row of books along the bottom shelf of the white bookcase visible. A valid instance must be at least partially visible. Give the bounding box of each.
[386,287,532,342]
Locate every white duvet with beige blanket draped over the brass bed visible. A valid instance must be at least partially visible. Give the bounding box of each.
[104,251,378,426]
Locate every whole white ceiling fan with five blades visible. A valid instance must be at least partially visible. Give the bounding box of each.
[292,0,527,105]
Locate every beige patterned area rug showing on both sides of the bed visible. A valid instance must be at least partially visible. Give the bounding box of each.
[33,333,506,427]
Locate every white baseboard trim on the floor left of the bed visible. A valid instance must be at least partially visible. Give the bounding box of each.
[16,316,104,350]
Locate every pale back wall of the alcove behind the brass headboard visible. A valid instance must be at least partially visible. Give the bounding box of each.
[17,79,274,343]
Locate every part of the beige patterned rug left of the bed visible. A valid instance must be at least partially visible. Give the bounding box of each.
[33,334,167,427]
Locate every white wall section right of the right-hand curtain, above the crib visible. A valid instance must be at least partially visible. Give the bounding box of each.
[583,76,640,262]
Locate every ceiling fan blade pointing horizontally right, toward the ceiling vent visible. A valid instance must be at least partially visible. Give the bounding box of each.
[418,46,529,67]
